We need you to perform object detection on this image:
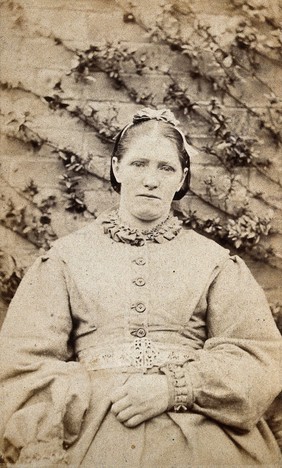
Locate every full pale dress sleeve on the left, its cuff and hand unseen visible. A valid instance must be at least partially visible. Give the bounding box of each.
[0,248,90,466]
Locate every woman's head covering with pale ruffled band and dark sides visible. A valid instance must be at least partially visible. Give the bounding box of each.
[110,107,190,200]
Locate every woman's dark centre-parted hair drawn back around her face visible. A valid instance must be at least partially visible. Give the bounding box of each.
[110,119,190,200]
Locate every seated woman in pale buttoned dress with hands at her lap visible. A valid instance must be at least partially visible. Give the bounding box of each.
[0,109,280,468]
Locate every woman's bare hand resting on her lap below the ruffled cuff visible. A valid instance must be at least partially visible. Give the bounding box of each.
[111,374,169,427]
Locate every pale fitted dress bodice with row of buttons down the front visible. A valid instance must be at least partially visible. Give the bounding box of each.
[50,210,228,367]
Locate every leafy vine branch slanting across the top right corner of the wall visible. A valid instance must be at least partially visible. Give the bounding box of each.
[151,3,282,145]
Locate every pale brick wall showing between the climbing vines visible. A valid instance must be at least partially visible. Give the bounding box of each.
[0,0,282,328]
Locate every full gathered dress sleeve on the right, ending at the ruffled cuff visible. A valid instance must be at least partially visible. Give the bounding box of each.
[183,257,281,430]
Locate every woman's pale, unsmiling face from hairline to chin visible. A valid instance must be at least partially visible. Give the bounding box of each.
[113,135,187,225]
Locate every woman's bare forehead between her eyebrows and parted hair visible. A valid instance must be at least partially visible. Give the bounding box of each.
[123,135,179,161]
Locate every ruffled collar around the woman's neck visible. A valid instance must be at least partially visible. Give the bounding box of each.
[100,210,182,246]
